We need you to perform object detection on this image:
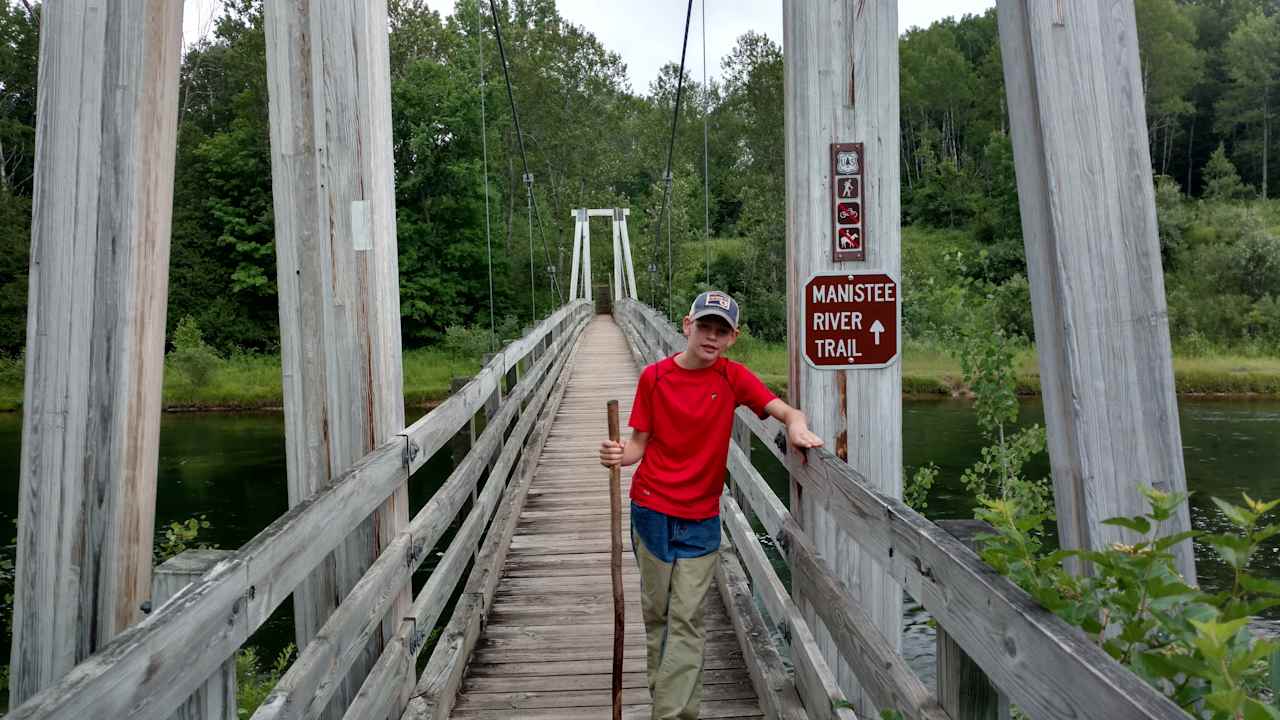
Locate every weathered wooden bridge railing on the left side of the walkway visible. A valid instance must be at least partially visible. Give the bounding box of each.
[8,301,590,720]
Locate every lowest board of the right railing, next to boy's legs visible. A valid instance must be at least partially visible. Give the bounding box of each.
[716,535,809,720]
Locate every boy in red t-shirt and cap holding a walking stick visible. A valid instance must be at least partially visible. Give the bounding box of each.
[600,291,822,720]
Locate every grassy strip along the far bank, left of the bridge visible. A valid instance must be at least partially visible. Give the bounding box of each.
[0,350,480,411]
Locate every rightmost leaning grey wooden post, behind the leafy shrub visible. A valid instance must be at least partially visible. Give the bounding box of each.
[998,0,1196,583]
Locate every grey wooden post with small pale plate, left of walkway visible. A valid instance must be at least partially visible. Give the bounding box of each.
[265,0,412,710]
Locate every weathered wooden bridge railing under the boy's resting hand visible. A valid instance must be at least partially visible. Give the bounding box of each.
[614,300,1187,720]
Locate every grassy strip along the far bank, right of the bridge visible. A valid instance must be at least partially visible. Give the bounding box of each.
[730,338,1280,396]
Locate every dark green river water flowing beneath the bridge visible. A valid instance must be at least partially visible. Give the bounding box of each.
[0,400,1280,673]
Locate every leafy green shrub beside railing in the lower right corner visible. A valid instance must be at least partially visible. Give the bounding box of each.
[977,488,1280,720]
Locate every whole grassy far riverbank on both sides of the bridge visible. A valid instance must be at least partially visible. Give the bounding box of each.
[0,340,1280,413]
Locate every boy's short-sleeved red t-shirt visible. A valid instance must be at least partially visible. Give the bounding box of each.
[630,356,777,520]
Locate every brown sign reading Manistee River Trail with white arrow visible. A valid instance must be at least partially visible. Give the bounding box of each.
[801,272,902,370]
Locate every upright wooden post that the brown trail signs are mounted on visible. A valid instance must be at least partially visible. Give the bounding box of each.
[778,0,902,716]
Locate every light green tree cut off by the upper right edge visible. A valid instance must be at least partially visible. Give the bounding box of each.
[1219,10,1280,200]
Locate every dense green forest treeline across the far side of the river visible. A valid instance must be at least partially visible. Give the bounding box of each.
[0,0,1280,356]
